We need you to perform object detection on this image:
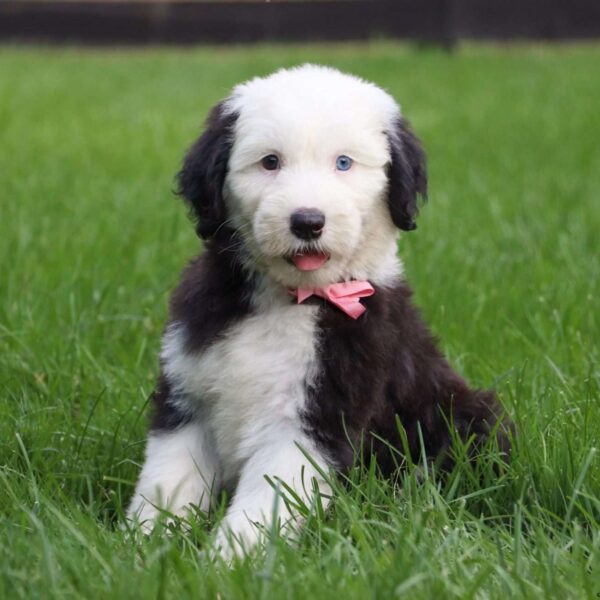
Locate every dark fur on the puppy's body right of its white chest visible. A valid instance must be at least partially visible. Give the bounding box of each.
[304,282,508,475]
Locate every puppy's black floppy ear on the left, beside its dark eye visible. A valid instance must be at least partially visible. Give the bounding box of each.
[177,102,237,239]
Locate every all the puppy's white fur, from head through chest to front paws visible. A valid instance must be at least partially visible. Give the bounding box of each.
[129,65,401,552]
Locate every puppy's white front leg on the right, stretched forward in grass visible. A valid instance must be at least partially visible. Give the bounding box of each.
[216,434,330,558]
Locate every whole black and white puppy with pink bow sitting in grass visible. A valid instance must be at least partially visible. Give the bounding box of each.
[128,65,507,552]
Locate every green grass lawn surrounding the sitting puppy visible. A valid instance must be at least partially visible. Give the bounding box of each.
[0,44,600,599]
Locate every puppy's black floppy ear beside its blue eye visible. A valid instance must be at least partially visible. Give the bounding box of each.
[388,118,427,231]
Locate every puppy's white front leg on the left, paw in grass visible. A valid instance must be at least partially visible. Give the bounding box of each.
[127,421,217,532]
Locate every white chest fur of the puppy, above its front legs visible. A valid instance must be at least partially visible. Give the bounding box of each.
[161,289,317,484]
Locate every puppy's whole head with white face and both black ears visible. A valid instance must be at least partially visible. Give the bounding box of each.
[180,65,425,287]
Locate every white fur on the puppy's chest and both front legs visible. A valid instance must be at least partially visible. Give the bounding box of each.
[129,281,328,552]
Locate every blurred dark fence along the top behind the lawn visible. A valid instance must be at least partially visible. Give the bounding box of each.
[0,0,600,44]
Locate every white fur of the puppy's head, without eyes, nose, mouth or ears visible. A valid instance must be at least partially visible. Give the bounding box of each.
[225,65,400,287]
